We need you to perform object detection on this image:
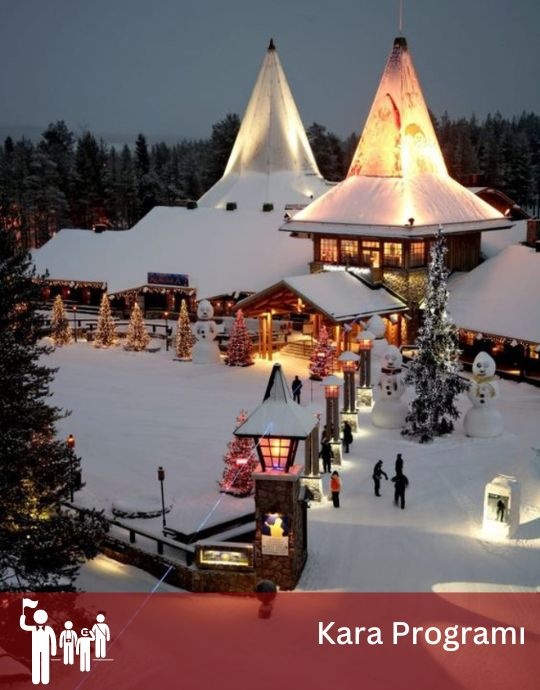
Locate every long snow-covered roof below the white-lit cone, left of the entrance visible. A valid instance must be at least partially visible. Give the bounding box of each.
[33,207,313,298]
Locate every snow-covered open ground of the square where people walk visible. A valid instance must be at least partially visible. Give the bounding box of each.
[48,343,540,591]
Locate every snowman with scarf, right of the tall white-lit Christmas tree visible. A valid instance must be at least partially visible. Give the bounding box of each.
[463,352,503,438]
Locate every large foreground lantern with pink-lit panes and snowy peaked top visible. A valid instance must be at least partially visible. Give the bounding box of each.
[234,364,315,473]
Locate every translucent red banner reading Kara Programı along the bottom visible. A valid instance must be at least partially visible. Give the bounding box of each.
[0,592,540,690]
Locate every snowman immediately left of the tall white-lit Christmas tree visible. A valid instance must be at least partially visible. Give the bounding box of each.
[371,345,407,429]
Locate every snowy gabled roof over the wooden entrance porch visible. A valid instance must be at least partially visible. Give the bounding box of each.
[238,271,406,322]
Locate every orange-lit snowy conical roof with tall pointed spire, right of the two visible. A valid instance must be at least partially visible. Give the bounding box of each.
[282,37,509,236]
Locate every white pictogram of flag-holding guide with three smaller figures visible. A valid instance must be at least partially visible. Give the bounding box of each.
[19,599,111,685]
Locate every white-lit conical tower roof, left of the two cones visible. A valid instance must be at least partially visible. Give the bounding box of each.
[199,40,328,210]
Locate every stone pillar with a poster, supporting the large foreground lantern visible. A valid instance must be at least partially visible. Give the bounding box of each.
[253,465,307,589]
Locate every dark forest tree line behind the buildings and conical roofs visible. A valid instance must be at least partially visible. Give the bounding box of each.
[0,113,540,247]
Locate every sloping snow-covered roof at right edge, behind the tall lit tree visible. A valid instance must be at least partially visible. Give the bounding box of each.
[448,245,540,343]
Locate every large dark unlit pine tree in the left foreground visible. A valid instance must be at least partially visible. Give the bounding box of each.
[0,231,104,591]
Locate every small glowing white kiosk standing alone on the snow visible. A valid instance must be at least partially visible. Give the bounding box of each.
[483,474,521,537]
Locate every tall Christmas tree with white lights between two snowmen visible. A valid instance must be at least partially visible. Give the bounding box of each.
[402,228,467,443]
